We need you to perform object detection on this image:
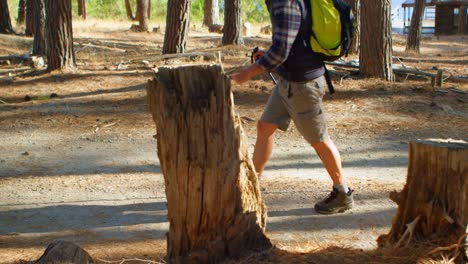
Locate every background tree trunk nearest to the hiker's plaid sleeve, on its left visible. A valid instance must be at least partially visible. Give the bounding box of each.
[222,0,243,45]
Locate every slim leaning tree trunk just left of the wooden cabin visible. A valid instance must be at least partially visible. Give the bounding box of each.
[406,0,426,53]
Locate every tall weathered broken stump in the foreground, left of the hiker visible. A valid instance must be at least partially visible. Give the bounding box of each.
[147,65,272,263]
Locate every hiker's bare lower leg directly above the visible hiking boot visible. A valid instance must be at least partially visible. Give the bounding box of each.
[312,139,344,185]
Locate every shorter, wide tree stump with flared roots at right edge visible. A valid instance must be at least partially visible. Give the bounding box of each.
[377,139,468,257]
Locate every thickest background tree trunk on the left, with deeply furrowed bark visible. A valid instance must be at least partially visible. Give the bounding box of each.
[46,0,76,71]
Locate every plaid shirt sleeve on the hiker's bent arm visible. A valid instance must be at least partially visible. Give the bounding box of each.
[257,0,302,71]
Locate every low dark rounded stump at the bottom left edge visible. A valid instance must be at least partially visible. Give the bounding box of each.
[35,240,95,264]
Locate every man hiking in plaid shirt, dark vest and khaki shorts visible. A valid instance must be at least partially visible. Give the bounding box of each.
[231,0,354,214]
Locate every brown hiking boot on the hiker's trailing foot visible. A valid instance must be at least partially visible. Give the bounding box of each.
[315,188,354,214]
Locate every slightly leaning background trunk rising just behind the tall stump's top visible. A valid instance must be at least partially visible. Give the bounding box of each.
[163,0,192,54]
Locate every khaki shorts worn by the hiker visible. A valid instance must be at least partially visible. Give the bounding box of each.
[260,76,329,144]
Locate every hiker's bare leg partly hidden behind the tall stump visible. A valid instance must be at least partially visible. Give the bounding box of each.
[253,121,278,177]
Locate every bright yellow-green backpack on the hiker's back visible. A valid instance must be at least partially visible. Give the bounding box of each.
[306,0,355,61]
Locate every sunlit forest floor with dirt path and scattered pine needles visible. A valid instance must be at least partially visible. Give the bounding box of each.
[0,21,468,263]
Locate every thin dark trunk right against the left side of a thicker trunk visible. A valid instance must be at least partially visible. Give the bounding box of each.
[33,0,46,56]
